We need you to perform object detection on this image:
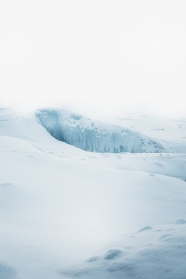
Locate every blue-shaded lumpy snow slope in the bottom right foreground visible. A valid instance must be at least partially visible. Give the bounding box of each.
[59,222,186,279]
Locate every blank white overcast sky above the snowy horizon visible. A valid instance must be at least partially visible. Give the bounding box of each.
[0,0,186,114]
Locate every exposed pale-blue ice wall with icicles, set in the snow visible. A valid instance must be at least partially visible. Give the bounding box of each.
[36,109,166,153]
